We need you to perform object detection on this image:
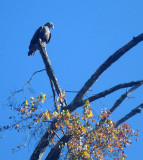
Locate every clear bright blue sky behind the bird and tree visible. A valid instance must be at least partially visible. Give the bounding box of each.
[0,0,143,160]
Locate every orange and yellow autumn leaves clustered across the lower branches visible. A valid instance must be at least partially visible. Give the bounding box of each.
[1,91,138,160]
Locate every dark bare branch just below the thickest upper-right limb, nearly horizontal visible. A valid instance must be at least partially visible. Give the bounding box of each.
[68,80,143,112]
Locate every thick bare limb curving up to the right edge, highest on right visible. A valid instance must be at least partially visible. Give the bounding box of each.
[72,33,143,103]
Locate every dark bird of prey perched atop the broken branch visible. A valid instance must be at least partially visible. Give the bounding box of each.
[28,22,54,56]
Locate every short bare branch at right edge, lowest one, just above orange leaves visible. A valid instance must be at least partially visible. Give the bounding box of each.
[115,103,143,127]
